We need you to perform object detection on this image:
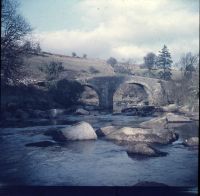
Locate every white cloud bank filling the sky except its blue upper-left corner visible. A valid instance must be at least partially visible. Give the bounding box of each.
[37,0,199,62]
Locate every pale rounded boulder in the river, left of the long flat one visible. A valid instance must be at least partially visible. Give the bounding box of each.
[58,121,97,140]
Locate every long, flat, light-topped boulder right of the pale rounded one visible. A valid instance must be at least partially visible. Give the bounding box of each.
[97,126,178,144]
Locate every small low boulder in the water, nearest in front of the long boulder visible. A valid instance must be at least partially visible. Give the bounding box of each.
[127,143,167,158]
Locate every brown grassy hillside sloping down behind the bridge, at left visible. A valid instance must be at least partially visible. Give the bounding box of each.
[24,52,115,80]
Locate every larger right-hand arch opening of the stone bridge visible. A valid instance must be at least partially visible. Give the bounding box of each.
[113,82,151,112]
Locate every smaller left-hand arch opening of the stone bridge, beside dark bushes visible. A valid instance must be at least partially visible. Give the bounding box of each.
[79,85,99,108]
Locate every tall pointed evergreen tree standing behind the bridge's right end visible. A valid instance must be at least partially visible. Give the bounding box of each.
[156,45,173,80]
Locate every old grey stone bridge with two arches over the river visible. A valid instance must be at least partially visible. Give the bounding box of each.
[77,75,167,111]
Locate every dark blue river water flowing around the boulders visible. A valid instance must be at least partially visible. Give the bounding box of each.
[0,114,198,187]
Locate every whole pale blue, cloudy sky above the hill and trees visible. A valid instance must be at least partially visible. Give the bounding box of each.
[19,0,199,63]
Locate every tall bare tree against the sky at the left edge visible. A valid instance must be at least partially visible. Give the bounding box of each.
[1,0,32,82]
